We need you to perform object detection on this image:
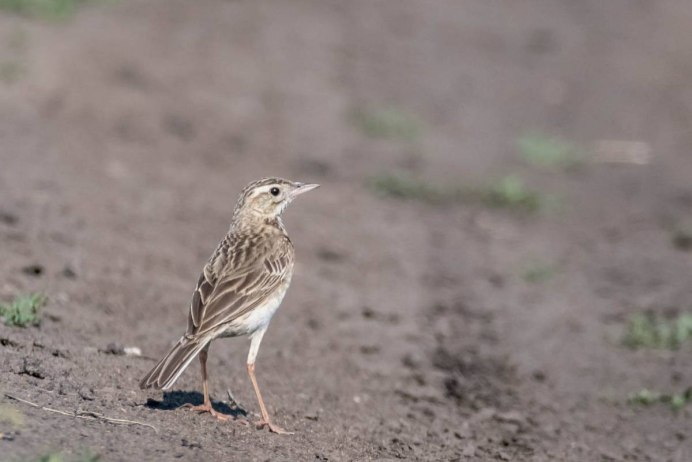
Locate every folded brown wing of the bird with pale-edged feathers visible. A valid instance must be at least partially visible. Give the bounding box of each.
[187,235,293,337]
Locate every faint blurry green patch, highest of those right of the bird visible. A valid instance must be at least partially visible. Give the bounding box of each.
[353,107,423,142]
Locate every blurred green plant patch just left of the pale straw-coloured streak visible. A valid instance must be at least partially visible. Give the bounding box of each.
[517,133,584,169]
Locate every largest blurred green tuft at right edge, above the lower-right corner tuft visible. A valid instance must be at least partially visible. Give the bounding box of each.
[622,313,692,350]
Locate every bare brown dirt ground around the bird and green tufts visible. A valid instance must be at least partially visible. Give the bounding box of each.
[0,0,692,461]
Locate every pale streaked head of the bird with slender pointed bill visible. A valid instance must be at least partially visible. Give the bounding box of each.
[233,178,319,220]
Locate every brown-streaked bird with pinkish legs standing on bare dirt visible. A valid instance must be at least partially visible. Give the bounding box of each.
[139,178,319,434]
